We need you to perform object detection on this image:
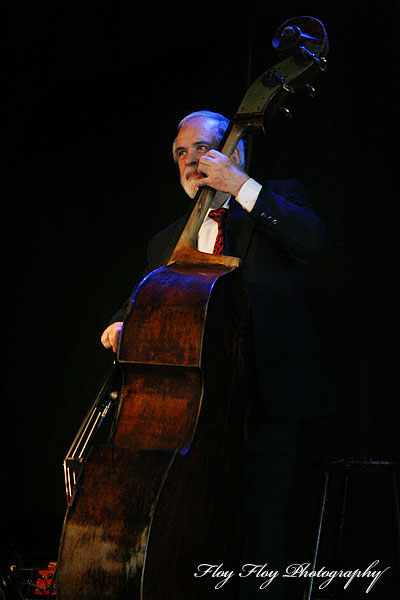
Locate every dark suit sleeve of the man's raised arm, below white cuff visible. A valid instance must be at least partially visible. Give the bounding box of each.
[249,179,325,262]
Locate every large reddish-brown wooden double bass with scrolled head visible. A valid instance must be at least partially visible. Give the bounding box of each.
[57,17,328,600]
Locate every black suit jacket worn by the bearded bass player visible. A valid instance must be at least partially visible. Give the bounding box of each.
[111,179,336,421]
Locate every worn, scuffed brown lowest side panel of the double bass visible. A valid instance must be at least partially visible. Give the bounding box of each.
[57,445,174,600]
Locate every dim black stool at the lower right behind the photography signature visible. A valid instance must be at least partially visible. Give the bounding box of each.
[305,457,400,600]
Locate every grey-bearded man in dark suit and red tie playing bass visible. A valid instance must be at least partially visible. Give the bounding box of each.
[101,111,334,600]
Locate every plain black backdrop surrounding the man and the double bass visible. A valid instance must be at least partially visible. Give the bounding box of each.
[1,0,399,596]
